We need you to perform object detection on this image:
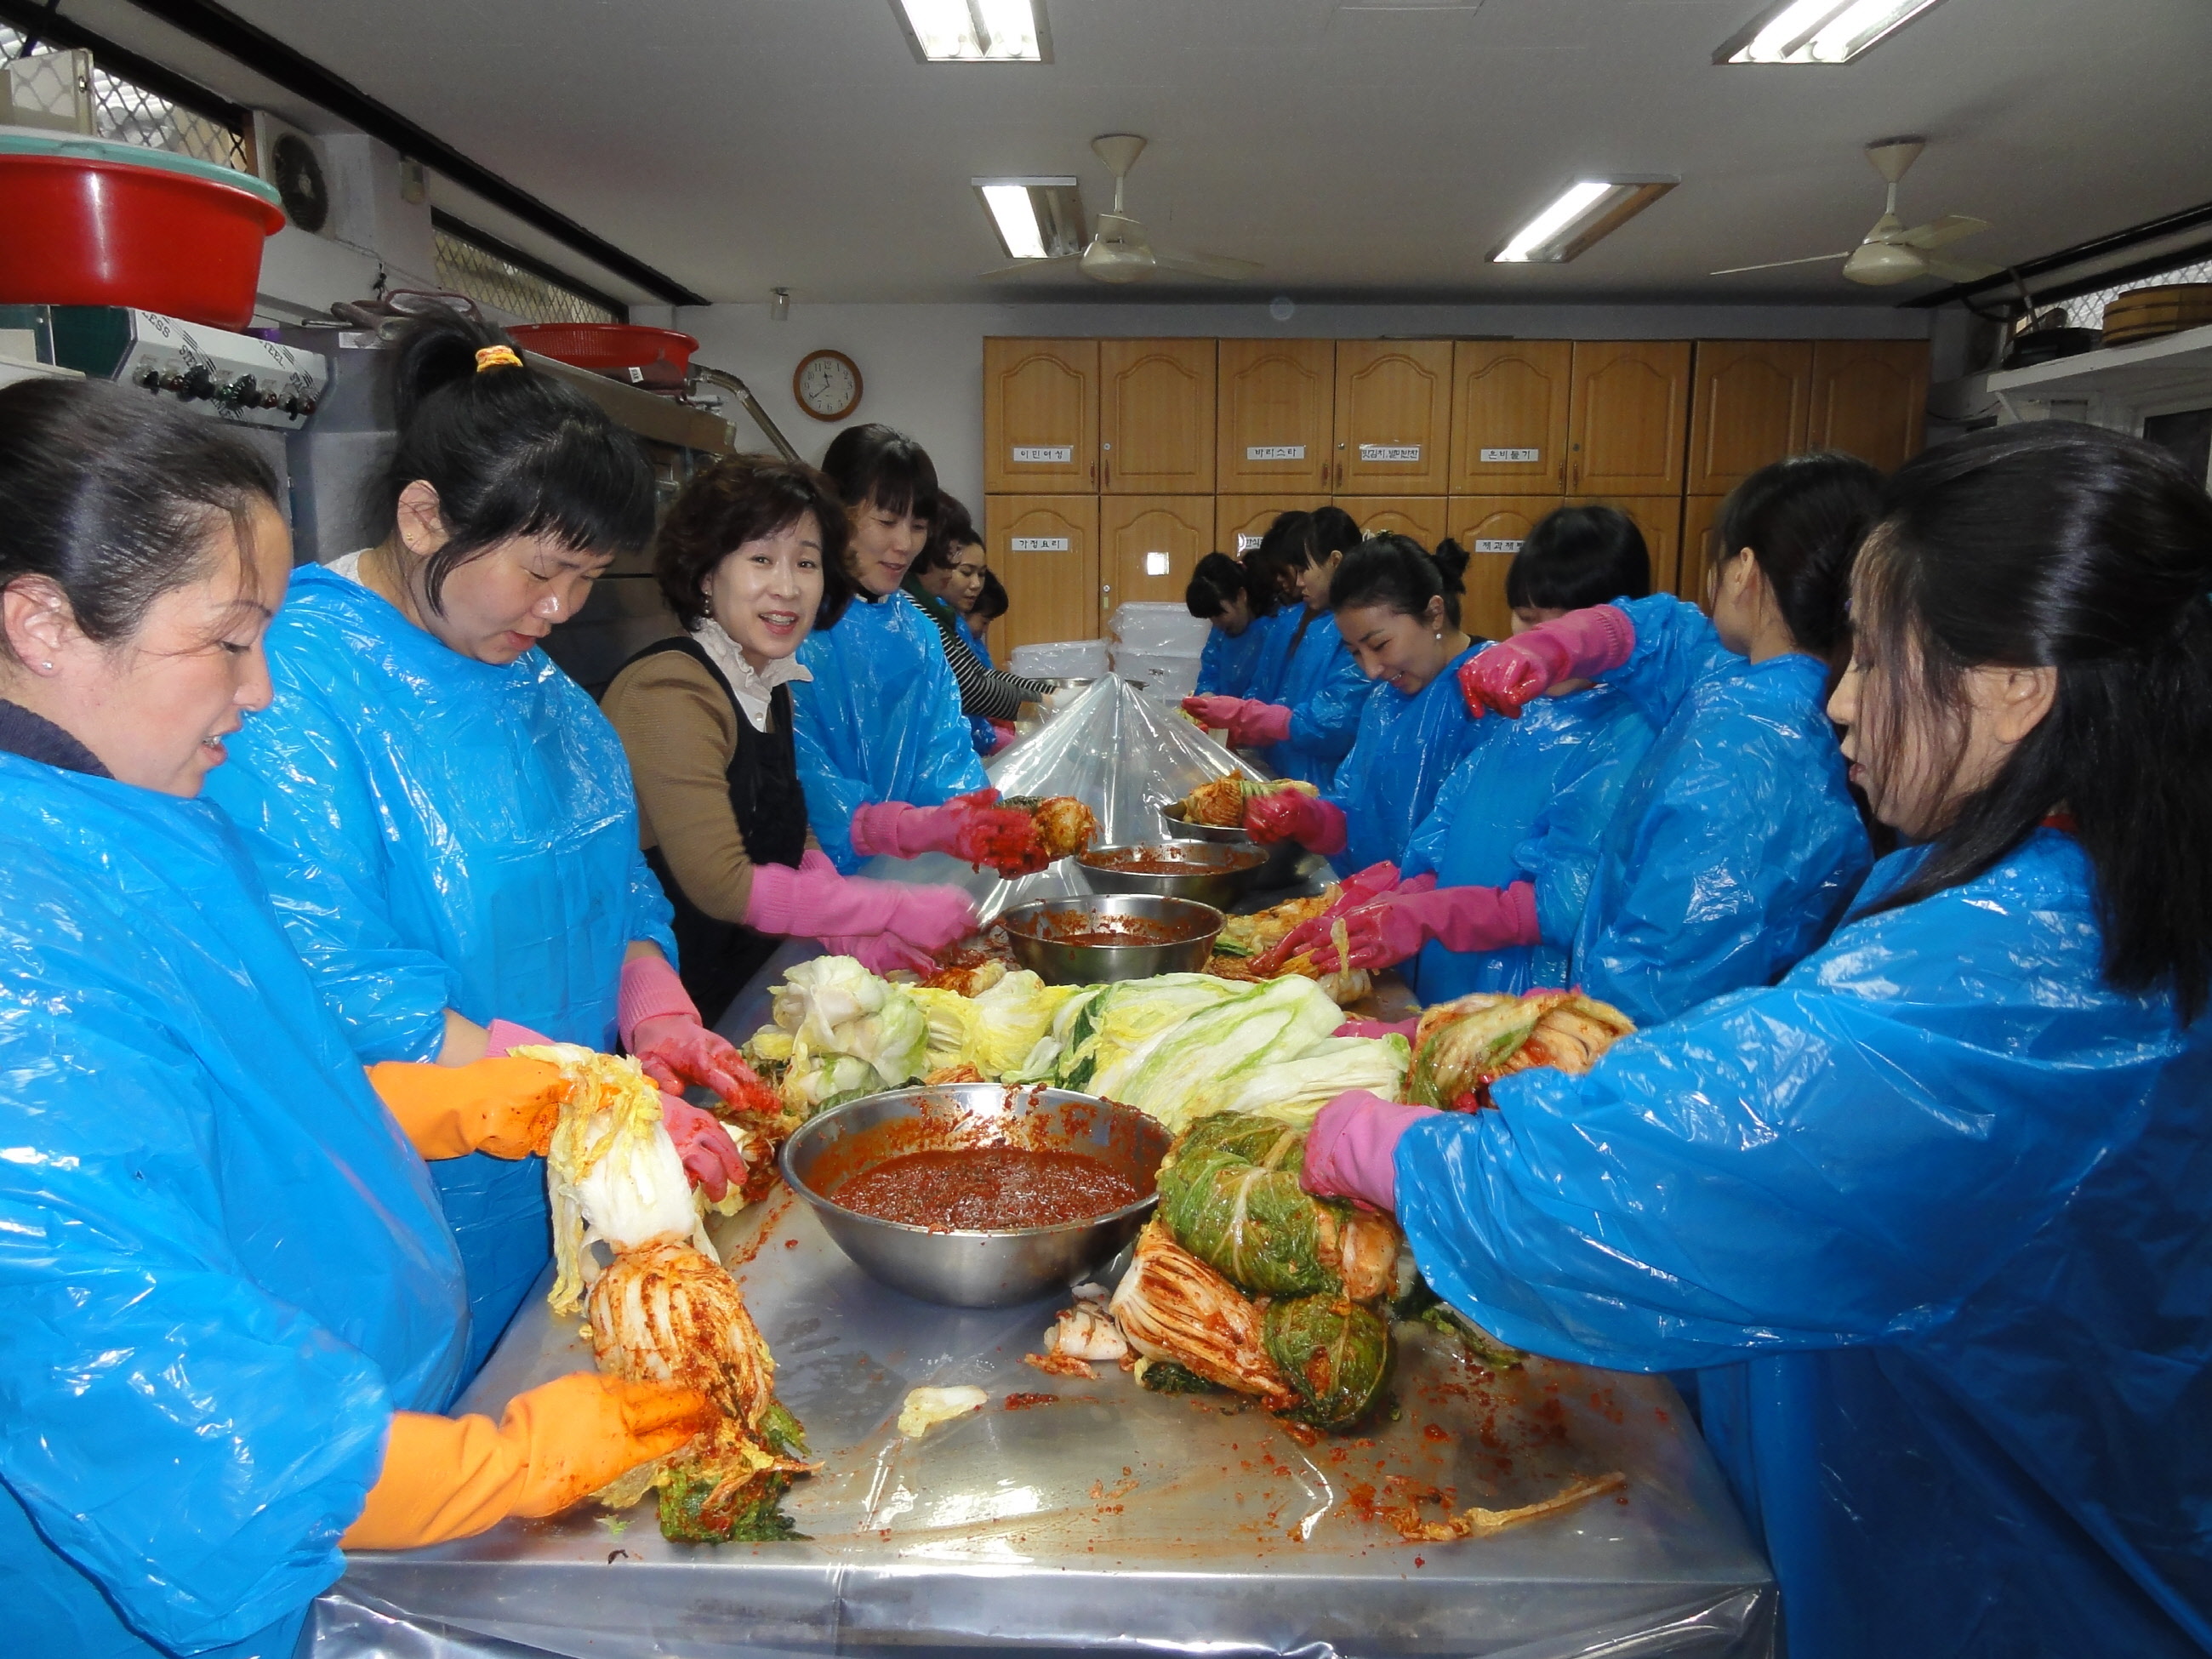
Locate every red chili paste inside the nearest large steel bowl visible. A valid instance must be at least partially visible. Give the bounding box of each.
[830,1146,1143,1232]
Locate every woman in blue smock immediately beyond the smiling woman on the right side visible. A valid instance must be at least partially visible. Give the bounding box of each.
[1183,506,1371,790]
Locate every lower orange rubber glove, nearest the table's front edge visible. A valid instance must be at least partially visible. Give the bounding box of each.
[339,1371,721,1551]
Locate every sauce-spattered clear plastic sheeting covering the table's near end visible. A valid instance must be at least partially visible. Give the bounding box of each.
[314,1194,1774,1659]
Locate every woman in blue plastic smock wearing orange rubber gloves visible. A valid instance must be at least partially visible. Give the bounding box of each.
[0,380,712,1659]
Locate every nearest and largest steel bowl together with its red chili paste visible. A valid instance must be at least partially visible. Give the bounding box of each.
[783,1084,1170,1308]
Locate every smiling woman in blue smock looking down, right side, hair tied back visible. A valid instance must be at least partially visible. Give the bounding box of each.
[1246,535,1475,889]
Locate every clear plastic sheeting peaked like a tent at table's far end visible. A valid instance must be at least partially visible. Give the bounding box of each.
[860,679,1272,938]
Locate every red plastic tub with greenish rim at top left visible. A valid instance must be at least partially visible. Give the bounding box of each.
[0,128,285,329]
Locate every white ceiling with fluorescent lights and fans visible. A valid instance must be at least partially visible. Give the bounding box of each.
[47,0,2212,305]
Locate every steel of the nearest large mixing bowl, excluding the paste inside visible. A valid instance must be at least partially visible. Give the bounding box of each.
[783,1084,1170,1308]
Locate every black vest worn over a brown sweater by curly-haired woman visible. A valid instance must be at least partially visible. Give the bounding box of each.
[624,639,807,1029]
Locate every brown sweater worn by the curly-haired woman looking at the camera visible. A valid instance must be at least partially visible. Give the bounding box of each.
[600,650,816,922]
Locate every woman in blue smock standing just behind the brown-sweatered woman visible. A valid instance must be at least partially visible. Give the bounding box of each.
[792,425,1026,876]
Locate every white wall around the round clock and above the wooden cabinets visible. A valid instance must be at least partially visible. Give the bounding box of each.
[672,301,1929,506]
